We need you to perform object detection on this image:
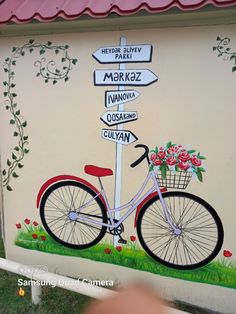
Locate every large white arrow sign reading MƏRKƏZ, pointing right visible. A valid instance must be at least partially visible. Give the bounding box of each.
[94,69,158,86]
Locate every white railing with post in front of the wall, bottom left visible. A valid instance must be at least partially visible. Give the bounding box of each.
[0,258,188,314]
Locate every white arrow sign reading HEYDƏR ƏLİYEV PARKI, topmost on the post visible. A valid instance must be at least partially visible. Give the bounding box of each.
[93,45,152,63]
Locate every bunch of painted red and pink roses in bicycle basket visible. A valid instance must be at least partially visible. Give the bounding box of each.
[150,141,206,182]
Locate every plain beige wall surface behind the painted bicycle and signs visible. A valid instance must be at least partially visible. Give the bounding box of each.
[0,25,236,313]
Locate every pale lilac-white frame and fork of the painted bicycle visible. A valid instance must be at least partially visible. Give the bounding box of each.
[78,170,179,234]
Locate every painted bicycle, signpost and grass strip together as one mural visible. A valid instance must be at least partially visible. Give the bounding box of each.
[12,39,236,288]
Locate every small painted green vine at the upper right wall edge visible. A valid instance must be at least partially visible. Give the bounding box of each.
[213,36,236,72]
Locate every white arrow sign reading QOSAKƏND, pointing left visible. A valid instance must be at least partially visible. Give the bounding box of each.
[100,111,138,126]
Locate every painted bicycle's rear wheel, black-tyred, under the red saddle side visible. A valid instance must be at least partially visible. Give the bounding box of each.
[40,181,107,249]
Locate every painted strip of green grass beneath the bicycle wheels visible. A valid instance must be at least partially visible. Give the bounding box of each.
[15,231,236,289]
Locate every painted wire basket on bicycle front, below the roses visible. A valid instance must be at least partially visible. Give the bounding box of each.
[157,170,192,189]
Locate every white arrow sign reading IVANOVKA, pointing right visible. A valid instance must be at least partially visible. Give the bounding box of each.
[105,89,140,108]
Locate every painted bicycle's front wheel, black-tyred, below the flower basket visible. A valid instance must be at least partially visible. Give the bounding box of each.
[137,192,224,270]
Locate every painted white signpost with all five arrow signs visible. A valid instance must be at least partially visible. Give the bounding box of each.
[93,37,158,246]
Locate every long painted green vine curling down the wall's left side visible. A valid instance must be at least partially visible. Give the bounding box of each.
[2,39,78,191]
